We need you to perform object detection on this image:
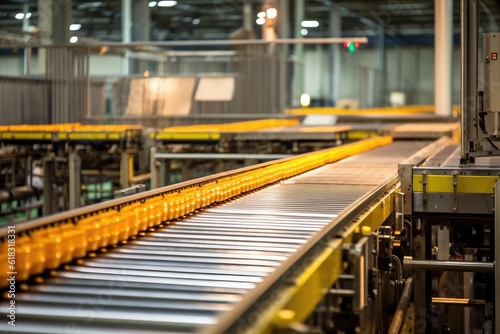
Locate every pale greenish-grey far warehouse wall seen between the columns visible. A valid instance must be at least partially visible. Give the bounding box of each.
[0,46,460,104]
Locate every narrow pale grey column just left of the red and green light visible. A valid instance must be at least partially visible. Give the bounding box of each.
[327,6,342,106]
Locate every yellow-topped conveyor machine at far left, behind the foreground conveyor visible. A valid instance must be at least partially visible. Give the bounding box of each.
[0,123,142,221]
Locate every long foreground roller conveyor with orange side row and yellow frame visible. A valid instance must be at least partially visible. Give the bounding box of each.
[0,137,438,333]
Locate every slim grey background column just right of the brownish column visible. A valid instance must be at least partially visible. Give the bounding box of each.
[292,0,305,105]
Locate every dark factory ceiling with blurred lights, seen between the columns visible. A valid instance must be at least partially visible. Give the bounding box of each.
[0,0,500,42]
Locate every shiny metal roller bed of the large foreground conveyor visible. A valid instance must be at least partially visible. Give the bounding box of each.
[0,137,427,333]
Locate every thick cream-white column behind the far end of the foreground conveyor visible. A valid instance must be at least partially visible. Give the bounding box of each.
[434,0,453,116]
